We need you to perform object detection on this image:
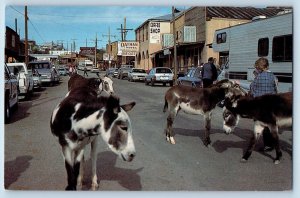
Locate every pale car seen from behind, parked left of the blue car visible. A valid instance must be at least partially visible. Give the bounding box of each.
[145,67,174,86]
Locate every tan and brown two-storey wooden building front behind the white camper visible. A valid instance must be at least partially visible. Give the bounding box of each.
[136,7,283,73]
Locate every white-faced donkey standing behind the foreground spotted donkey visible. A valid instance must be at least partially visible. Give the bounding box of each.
[68,74,114,94]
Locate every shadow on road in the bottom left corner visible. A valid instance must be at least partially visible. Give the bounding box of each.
[4,155,33,189]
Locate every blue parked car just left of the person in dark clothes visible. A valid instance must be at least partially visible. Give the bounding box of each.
[177,67,202,87]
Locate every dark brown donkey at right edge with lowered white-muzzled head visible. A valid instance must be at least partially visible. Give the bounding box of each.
[223,92,293,164]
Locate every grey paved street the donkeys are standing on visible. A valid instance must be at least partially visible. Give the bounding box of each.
[4,74,293,191]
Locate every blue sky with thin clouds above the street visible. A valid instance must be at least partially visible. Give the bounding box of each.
[5,5,177,50]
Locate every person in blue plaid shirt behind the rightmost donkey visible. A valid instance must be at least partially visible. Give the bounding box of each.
[249,58,278,151]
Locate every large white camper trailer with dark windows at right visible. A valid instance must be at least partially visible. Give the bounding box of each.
[212,12,293,82]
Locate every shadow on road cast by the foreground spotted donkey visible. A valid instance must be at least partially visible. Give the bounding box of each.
[83,151,143,191]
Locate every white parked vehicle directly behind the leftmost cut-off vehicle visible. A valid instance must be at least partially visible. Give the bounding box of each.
[6,63,33,98]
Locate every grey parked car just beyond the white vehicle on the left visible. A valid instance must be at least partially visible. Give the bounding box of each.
[28,61,55,85]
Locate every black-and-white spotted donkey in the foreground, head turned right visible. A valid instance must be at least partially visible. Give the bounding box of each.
[50,87,135,190]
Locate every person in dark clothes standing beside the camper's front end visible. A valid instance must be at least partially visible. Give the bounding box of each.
[201,57,218,88]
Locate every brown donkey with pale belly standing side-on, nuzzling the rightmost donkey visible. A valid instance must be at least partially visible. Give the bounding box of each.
[163,79,243,146]
